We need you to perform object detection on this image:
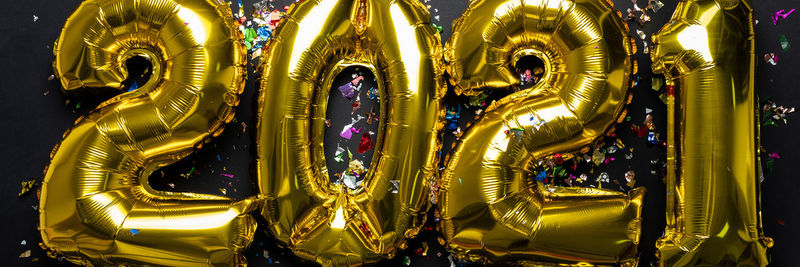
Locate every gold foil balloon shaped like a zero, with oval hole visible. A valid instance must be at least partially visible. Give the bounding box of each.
[256,0,444,265]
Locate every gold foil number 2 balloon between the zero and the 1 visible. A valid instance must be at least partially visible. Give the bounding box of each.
[439,0,644,265]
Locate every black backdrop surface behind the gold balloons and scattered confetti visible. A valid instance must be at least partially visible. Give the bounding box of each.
[0,0,800,266]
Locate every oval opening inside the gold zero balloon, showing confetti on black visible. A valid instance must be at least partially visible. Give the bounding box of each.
[323,66,380,190]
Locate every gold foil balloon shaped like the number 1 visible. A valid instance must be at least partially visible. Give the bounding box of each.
[651,0,772,266]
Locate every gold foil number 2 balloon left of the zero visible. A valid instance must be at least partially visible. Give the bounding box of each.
[39,0,257,266]
